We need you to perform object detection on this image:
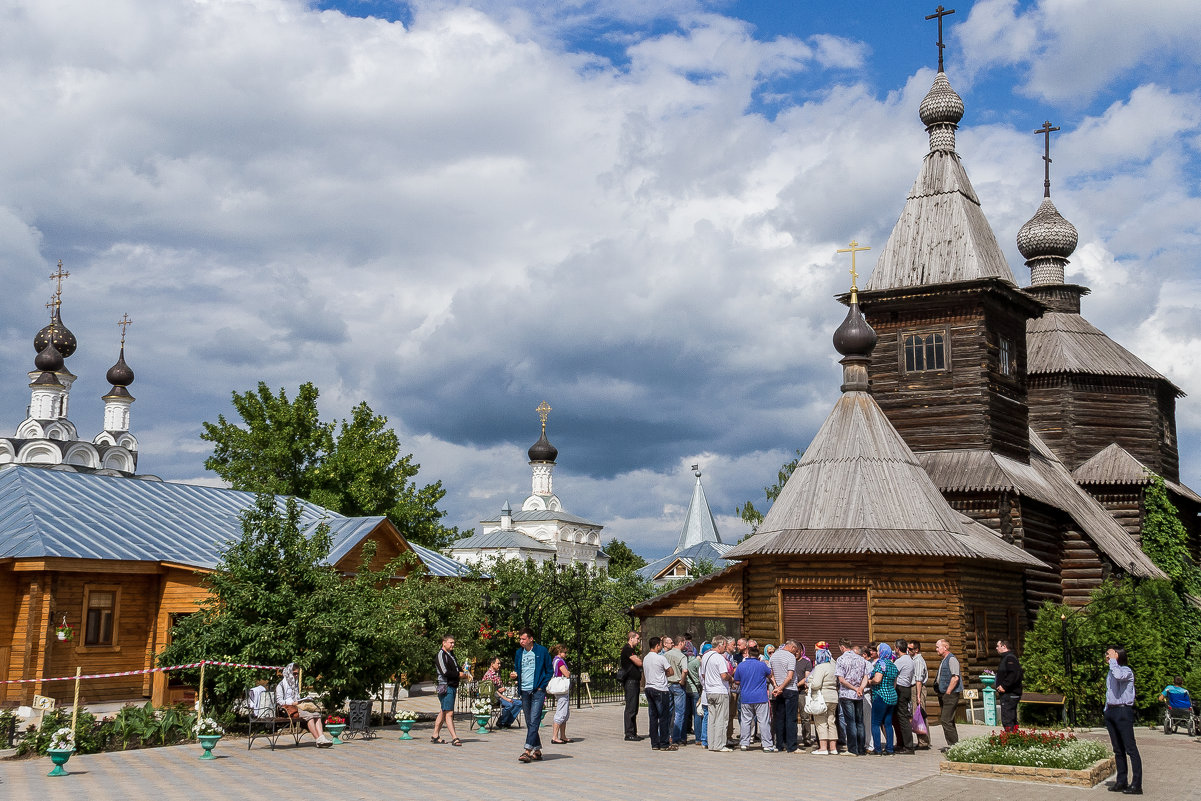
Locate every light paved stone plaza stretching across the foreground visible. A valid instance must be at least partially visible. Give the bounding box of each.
[0,705,1201,801]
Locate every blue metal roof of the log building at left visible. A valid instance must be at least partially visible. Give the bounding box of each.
[0,465,459,575]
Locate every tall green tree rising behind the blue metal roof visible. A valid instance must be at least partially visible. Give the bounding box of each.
[201,382,459,548]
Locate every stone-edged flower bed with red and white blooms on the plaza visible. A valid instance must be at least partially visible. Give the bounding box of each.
[942,730,1113,787]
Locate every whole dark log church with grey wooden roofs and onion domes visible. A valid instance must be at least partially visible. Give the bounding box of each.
[634,15,1201,675]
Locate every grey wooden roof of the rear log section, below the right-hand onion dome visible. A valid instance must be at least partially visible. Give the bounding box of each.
[1026,312,1184,396]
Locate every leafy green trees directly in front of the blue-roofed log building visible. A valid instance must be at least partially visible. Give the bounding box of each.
[159,494,479,709]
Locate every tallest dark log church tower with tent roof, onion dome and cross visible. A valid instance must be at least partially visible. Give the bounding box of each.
[859,6,1042,462]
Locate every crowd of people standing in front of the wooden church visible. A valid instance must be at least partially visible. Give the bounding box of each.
[617,632,994,757]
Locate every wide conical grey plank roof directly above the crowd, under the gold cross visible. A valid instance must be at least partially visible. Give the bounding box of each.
[725,391,1045,567]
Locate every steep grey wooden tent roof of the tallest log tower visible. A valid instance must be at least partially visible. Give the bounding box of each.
[864,150,1017,292]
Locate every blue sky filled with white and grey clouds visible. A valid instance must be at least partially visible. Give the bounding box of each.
[0,0,1201,556]
